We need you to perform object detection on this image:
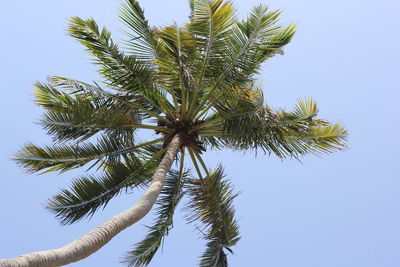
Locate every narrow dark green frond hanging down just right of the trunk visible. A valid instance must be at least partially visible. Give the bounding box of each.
[125,170,189,266]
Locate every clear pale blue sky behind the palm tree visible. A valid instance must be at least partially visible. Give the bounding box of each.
[0,0,400,267]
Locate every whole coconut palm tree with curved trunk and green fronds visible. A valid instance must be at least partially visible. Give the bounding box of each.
[0,0,347,266]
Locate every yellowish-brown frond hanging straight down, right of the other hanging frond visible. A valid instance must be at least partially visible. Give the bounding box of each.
[186,166,240,267]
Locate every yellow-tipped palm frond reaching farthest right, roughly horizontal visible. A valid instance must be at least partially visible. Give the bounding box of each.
[224,100,347,158]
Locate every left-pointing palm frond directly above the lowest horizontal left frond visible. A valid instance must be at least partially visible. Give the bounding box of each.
[35,80,143,141]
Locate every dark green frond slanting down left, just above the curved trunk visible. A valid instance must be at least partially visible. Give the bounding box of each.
[47,157,157,224]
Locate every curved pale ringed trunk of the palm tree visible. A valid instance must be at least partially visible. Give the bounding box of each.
[0,133,183,267]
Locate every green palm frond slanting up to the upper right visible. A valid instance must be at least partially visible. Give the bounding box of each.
[191,3,295,119]
